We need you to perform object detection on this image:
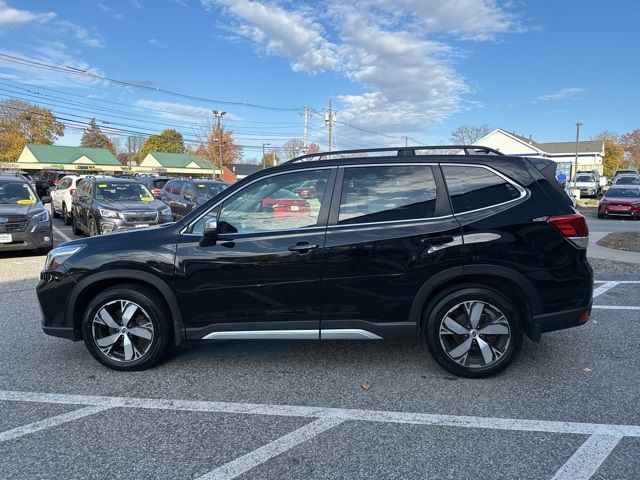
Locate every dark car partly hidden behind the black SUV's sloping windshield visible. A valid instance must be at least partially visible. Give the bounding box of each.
[160,178,229,219]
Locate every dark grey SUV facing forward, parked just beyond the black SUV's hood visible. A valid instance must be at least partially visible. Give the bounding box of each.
[71,177,171,236]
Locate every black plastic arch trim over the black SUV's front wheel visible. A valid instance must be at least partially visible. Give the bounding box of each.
[65,269,184,345]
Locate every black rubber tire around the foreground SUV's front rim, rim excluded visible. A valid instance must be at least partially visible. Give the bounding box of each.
[82,284,173,371]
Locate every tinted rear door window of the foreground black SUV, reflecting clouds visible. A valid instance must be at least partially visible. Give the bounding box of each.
[338,165,436,224]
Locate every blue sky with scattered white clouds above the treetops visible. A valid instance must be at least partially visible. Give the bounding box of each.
[0,0,640,158]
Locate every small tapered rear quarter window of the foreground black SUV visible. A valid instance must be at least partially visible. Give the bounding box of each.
[442,165,520,213]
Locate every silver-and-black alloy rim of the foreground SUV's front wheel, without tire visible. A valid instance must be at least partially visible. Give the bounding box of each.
[91,300,154,362]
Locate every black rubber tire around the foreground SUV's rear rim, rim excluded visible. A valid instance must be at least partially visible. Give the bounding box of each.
[423,286,523,378]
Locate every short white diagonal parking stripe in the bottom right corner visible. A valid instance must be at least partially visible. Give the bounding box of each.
[551,435,622,480]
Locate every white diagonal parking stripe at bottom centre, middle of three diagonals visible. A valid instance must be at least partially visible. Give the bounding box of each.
[197,417,344,480]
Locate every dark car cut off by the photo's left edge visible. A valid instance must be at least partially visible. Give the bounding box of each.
[0,175,53,253]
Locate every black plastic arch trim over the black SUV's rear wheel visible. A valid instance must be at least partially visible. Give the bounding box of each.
[410,265,541,342]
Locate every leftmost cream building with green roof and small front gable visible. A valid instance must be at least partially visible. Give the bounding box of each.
[17,143,122,172]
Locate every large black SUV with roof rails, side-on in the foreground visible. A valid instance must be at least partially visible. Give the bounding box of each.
[37,147,593,377]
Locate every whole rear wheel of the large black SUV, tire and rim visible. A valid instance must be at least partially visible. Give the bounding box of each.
[424,287,522,378]
